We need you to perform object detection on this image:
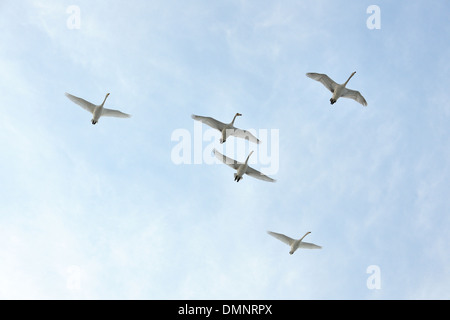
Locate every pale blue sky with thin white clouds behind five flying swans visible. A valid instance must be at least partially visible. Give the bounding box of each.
[0,0,450,299]
